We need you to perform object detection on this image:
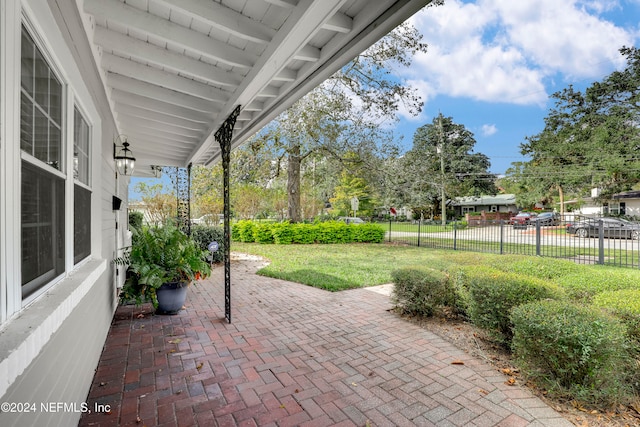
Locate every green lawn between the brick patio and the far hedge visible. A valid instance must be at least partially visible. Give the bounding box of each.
[231,242,497,291]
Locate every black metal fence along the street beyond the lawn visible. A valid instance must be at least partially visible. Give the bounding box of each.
[382,215,640,268]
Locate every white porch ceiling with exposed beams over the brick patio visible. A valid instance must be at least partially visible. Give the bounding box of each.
[77,0,430,176]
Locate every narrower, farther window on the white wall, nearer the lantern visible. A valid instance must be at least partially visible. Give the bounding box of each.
[73,108,91,264]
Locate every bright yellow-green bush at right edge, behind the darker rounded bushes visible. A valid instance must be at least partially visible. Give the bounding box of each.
[556,266,640,302]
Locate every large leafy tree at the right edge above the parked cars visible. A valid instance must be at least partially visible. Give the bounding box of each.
[507,47,640,208]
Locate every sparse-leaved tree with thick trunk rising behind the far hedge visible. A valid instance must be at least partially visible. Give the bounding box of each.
[256,18,426,222]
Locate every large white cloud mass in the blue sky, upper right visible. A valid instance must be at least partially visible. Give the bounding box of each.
[405,0,638,118]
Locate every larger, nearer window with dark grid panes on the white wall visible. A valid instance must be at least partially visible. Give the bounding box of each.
[20,27,65,298]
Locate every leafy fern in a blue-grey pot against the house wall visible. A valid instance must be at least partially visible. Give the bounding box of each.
[114,223,211,314]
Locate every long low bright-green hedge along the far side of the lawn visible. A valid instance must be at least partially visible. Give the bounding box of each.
[231,220,385,245]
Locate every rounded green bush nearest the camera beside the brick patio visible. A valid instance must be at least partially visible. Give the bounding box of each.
[511,300,634,404]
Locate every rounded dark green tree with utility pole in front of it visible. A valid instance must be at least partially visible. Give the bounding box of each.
[398,114,496,221]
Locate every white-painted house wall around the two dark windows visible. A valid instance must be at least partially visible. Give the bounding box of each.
[0,0,128,426]
